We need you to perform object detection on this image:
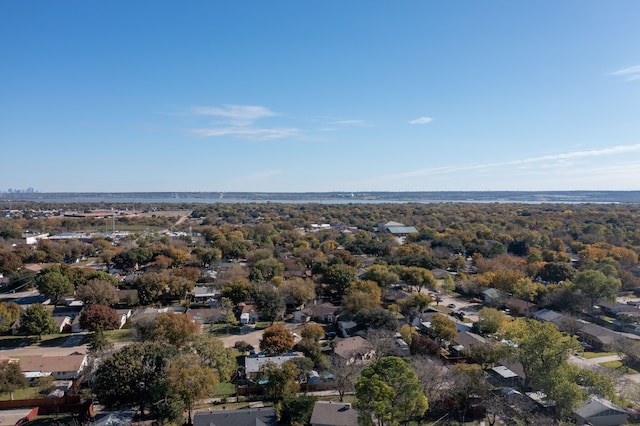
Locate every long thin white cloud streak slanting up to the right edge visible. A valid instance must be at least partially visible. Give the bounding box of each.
[382,144,640,179]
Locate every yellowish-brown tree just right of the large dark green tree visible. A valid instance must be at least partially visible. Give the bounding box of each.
[168,354,219,425]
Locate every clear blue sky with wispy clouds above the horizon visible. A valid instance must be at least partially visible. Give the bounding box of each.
[0,0,640,192]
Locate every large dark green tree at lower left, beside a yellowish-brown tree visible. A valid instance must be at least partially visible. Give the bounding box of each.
[93,342,176,414]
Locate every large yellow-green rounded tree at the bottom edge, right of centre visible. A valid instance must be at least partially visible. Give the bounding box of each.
[356,356,429,426]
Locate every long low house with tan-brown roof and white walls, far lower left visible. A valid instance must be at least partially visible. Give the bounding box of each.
[20,354,87,380]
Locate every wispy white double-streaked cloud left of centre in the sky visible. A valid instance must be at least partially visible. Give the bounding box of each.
[184,105,300,141]
